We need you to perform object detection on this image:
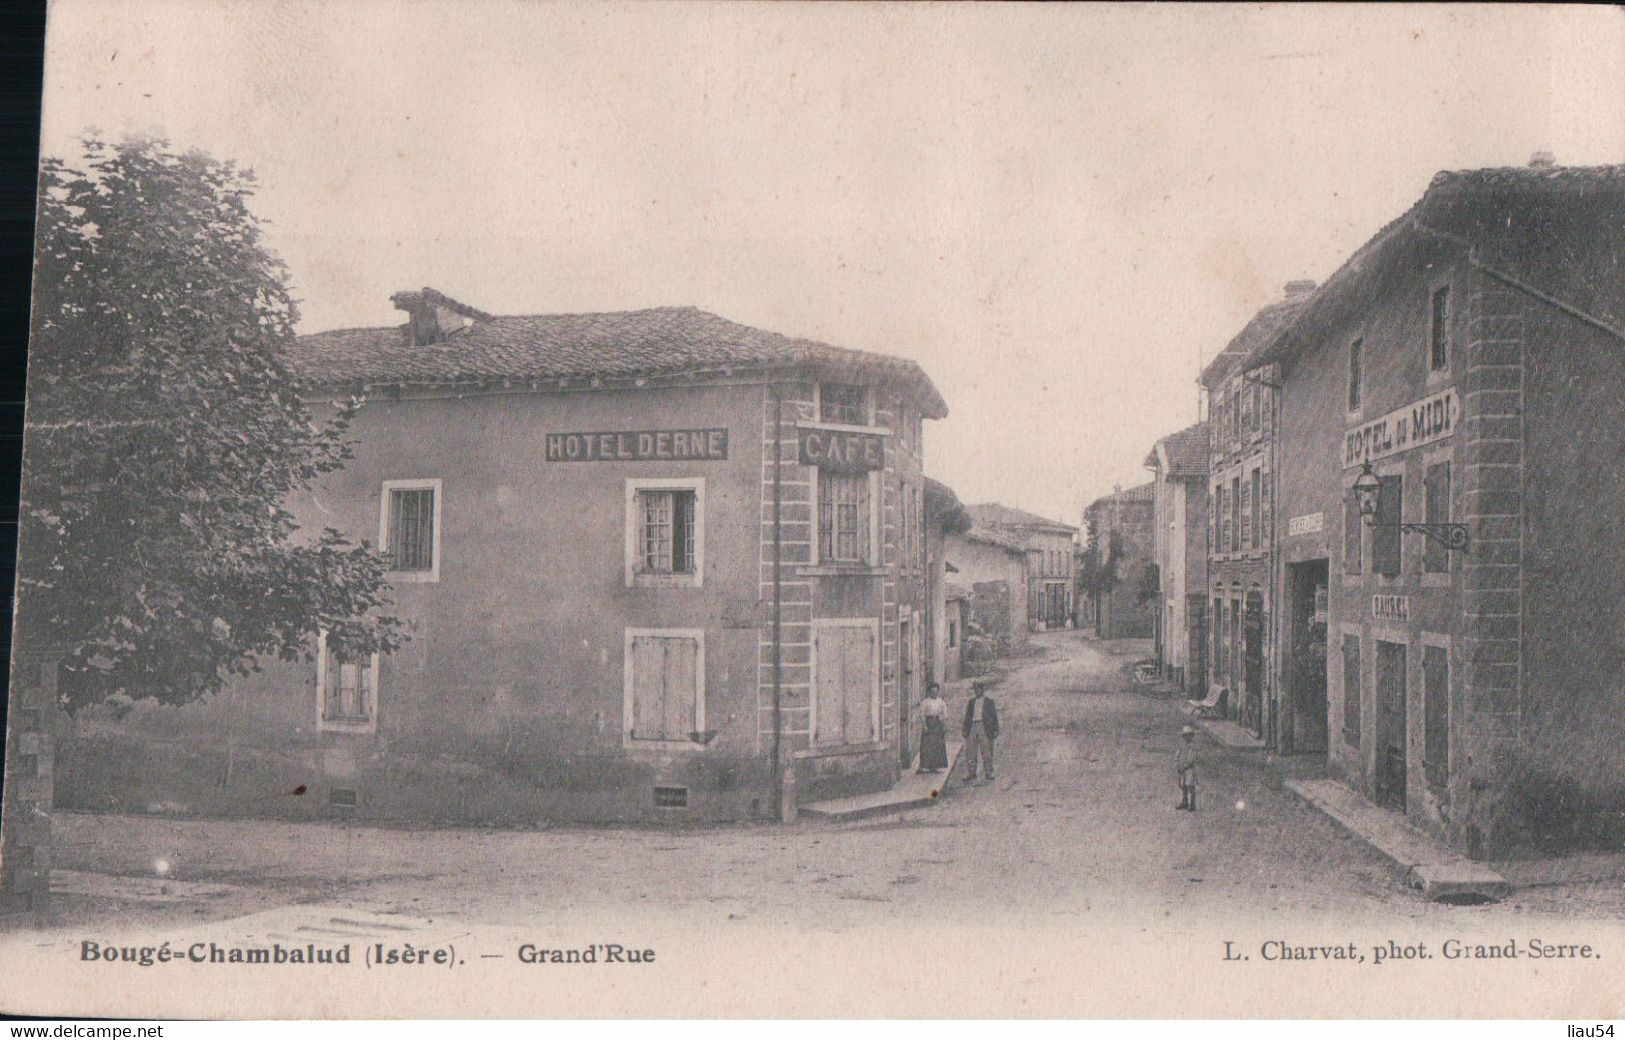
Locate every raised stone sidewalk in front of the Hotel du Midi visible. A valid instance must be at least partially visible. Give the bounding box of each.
[1287,780,1510,902]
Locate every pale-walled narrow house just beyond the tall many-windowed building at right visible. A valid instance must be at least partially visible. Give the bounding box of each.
[1146,423,1207,692]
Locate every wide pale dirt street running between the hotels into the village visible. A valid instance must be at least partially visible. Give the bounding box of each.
[25,632,1625,931]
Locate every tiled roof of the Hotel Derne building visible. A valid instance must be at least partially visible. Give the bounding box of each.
[291,307,947,418]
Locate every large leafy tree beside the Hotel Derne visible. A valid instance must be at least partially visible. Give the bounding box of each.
[18,140,403,710]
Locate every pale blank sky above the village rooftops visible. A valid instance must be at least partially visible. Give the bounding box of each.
[42,0,1625,523]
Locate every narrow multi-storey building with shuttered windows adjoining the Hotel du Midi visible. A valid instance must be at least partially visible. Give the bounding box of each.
[1201,281,1315,739]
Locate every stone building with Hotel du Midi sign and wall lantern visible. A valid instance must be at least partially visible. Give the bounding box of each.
[1248,156,1625,856]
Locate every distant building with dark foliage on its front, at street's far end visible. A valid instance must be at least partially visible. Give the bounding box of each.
[1084,483,1157,639]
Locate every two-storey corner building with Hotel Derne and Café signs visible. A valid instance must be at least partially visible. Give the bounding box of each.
[59,289,946,822]
